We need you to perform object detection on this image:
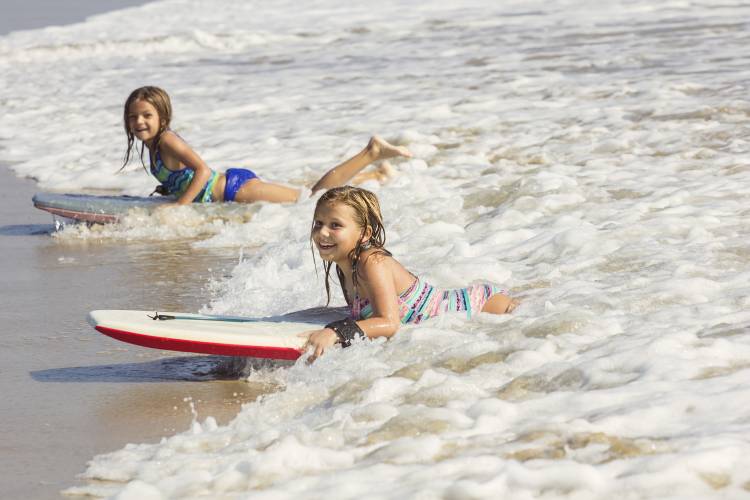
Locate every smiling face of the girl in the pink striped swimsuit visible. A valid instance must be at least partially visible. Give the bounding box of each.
[312,203,367,267]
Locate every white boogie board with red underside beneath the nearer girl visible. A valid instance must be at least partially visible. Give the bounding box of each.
[88,309,341,359]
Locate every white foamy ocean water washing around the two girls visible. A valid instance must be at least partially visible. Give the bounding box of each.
[0,0,750,499]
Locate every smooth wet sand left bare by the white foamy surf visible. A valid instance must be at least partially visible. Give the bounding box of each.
[0,0,269,499]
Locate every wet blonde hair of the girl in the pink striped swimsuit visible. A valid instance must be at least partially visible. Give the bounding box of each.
[310,186,391,305]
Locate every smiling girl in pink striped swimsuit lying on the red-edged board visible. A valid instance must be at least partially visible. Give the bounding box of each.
[303,186,517,359]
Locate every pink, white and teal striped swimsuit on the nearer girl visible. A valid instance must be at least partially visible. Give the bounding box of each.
[351,277,508,324]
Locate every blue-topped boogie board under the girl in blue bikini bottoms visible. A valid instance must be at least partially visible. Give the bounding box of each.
[32,193,174,223]
